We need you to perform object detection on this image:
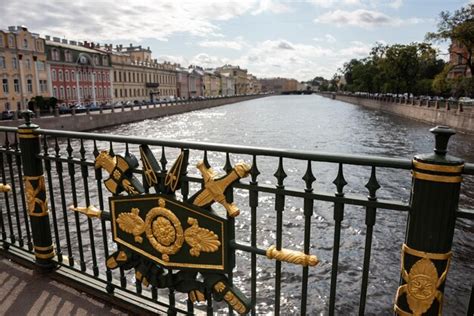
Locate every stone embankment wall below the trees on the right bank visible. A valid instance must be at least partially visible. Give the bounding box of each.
[321,93,474,134]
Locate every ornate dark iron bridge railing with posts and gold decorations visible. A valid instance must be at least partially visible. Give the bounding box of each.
[0,114,474,315]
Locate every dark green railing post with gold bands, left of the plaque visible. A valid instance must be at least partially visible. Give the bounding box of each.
[18,111,55,271]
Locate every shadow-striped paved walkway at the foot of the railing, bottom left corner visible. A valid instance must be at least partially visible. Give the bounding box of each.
[0,255,126,316]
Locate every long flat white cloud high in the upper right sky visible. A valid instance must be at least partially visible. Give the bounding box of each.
[314,9,423,28]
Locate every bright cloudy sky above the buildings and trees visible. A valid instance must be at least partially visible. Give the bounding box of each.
[0,0,474,80]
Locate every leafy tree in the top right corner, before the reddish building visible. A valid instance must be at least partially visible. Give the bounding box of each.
[426,4,474,76]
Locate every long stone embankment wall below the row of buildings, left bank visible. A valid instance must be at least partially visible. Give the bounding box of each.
[0,95,265,131]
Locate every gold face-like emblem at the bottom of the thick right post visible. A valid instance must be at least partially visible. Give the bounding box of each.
[394,244,451,315]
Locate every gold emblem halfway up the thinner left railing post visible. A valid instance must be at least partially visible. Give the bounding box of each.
[23,175,48,216]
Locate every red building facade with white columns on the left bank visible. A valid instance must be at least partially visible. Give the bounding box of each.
[46,35,112,106]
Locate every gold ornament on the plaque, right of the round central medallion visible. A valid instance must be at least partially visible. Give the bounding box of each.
[184,217,221,257]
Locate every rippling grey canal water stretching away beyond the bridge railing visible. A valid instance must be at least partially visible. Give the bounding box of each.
[91,95,474,315]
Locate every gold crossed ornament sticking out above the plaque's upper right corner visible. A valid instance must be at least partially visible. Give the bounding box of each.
[192,161,250,217]
